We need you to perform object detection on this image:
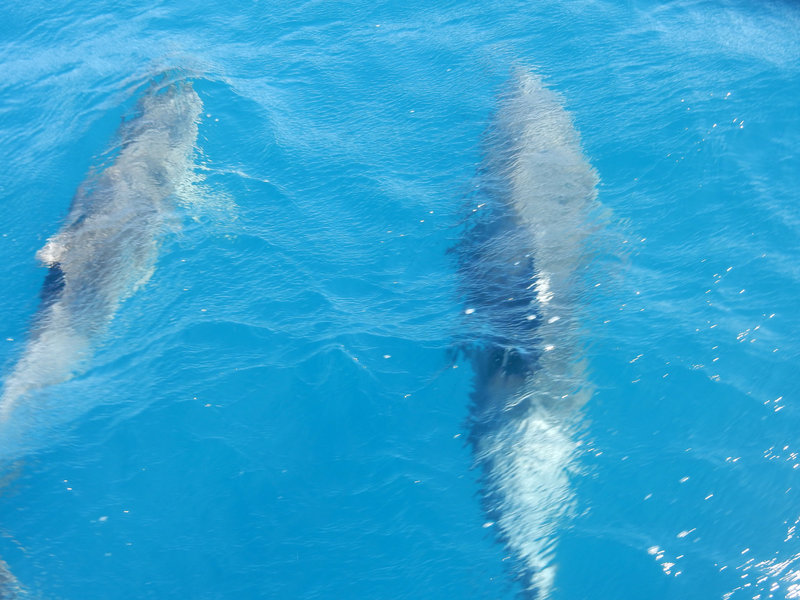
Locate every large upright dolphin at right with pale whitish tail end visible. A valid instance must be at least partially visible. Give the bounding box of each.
[456,70,598,598]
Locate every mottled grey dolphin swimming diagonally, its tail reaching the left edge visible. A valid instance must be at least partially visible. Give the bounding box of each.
[0,75,202,423]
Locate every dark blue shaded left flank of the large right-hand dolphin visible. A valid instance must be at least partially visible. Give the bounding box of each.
[451,184,541,600]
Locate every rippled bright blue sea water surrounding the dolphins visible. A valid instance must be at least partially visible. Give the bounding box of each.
[0,0,800,599]
